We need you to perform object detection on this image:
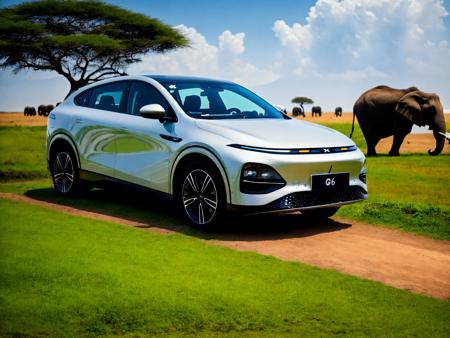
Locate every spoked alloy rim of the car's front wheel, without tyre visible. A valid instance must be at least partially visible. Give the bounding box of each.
[182,169,218,225]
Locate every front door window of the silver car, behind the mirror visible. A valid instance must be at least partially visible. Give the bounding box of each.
[127,81,170,115]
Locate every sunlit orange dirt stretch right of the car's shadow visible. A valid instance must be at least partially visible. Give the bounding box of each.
[214,218,450,299]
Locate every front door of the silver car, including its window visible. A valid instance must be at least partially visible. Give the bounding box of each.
[114,81,181,192]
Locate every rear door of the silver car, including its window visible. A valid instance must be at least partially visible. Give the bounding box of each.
[74,81,129,176]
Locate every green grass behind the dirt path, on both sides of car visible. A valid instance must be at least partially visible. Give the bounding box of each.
[0,123,450,240]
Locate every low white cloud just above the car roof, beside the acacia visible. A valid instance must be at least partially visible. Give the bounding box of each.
[129,25,279,86]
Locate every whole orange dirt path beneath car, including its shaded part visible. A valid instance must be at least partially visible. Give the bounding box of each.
[0,193,450,299]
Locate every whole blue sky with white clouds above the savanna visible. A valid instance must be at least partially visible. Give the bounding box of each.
[0,0,450,111]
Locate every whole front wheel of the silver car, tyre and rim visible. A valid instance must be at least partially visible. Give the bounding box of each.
[176,161,226,230]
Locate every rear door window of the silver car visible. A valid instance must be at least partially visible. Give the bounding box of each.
[89,82,127,112]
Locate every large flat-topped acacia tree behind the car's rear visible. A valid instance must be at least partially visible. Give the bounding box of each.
[0,0,188,93]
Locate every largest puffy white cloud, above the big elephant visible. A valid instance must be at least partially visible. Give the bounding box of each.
[272,0,450,109]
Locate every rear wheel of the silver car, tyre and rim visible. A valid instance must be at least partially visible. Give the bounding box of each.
[50,146,84,196]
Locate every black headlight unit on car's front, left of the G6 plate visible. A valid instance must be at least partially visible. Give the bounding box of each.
[240,163,286,194]
